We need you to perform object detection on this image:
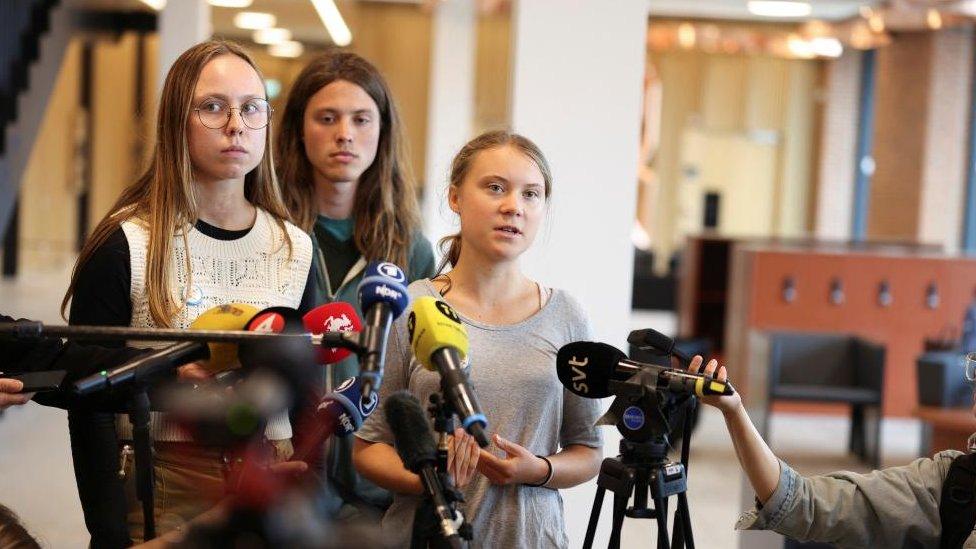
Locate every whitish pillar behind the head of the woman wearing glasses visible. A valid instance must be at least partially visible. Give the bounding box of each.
[156,0,213,90]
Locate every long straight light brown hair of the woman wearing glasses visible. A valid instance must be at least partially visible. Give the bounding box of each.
[61,40,292,327]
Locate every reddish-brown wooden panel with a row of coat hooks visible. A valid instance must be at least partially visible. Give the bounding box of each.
[726,247,976,416]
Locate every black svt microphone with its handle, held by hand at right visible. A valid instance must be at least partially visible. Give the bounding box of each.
[556,341,735,398]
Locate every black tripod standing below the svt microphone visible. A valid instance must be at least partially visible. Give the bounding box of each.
[583,398,697,549]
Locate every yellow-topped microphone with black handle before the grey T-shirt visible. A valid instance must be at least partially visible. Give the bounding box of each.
[407,296,488,448]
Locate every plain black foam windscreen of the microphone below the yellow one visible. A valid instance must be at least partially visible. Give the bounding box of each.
[383,391,437,473]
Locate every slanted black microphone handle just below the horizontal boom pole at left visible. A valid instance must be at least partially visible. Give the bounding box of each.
[74,341,210,396]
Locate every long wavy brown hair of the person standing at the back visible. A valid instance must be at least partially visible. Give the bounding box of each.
[277,50,420,268]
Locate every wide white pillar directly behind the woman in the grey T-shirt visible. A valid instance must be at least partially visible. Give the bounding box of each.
[512,0,649,547]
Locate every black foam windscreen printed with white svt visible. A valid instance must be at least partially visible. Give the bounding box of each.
[556,341,627,398]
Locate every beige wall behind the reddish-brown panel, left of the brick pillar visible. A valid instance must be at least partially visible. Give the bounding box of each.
[652,50,820,271]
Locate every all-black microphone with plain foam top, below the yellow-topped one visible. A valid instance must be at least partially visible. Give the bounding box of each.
[383,390,461,548]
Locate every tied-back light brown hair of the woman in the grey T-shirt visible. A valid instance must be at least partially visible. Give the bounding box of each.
[437,130,552,274]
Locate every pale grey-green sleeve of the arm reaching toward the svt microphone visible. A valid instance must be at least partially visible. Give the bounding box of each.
[736,451,959,547]
